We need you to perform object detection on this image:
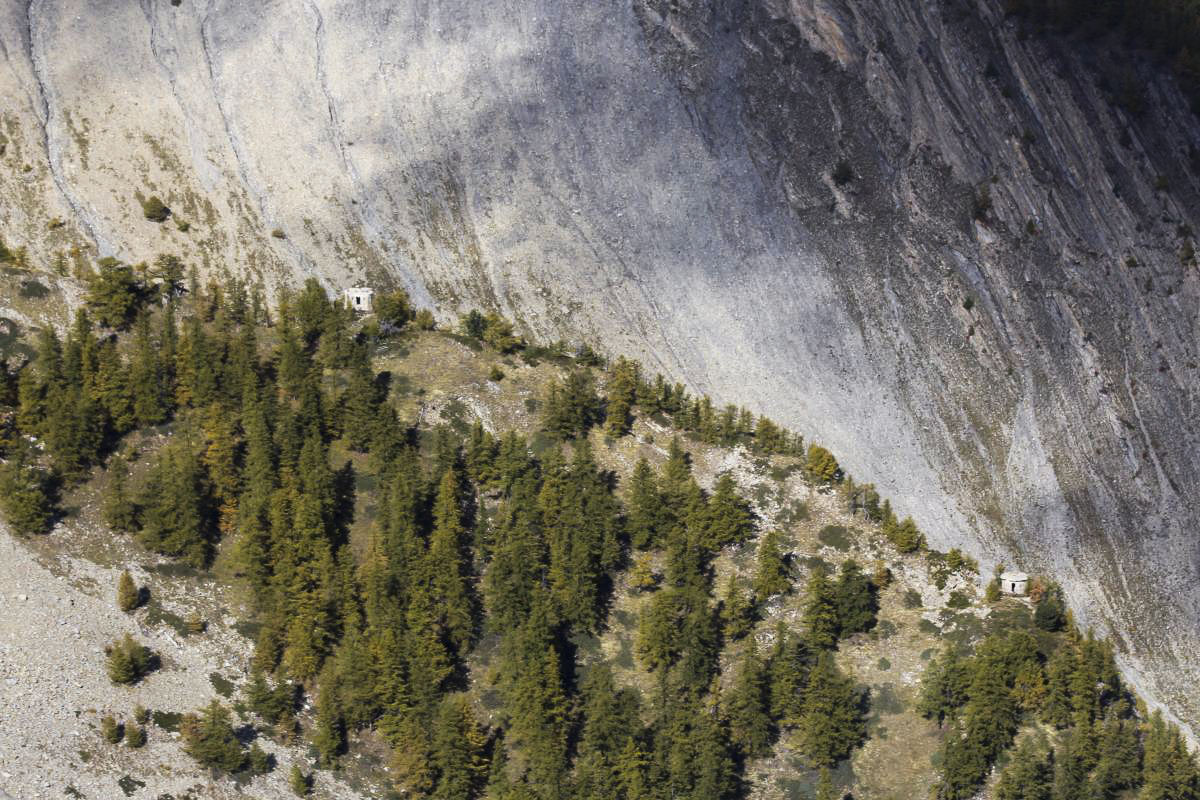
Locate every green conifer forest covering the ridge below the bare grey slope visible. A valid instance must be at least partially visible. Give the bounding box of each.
[0,257,1200,800]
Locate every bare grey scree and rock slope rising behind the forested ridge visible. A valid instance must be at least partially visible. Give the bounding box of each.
[0,0,1200,723]
